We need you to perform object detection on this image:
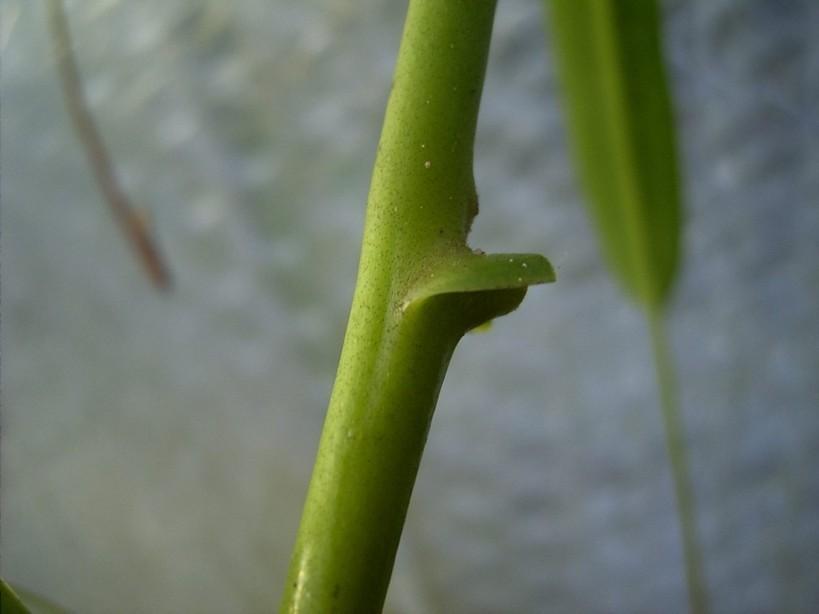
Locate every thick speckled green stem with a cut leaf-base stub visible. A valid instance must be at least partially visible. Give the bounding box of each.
[281,0,553,614]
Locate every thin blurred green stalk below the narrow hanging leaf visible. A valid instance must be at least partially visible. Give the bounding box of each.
[647,310,709,614]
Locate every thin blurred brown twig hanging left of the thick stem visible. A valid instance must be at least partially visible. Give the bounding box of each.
[48,0,171,290]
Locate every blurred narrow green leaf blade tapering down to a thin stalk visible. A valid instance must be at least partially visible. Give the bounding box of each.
[548,0,681,310]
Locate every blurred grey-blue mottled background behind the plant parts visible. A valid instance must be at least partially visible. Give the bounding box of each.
[0,0,819,614]
